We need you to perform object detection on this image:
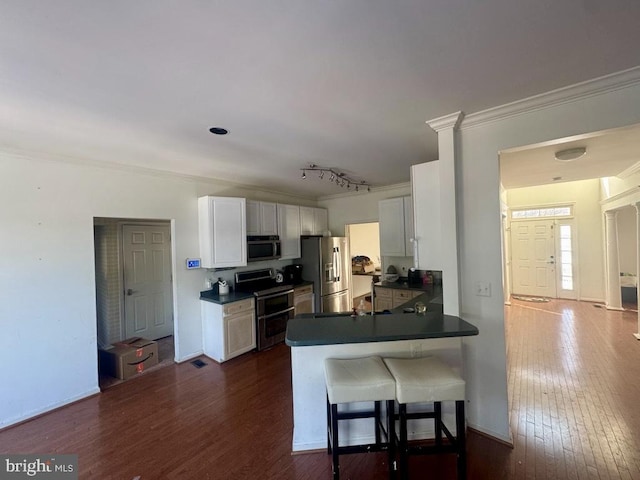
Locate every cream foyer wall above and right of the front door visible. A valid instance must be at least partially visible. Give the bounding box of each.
[507,178,604,301]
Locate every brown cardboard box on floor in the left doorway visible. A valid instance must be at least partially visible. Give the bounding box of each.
[100,337,158,380]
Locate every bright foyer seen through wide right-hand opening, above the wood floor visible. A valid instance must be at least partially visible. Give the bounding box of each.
[498,125,640,310]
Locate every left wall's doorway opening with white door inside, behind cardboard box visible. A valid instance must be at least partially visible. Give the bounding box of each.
[94,217,175,389]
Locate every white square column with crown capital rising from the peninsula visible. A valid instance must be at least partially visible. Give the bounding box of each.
[427,112,464,316]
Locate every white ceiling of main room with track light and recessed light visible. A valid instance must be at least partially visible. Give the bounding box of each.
[0,0,640,196]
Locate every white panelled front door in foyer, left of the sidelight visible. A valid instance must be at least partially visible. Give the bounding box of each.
[511,220,557,298]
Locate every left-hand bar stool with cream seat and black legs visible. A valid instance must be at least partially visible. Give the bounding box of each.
[324,356,396,480]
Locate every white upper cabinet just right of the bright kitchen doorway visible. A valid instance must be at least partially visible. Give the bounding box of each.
[378,197,413,257]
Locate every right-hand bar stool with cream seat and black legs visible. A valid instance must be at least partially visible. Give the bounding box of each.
[384,357,467,480]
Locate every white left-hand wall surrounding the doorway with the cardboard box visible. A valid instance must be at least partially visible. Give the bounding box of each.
[0,154,313,427]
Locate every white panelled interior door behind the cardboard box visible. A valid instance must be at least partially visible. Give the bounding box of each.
[122,225,173,340]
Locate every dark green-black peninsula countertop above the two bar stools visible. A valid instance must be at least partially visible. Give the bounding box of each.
[285,311,478,347]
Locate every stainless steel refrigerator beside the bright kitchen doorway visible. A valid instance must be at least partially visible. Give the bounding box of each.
[300,237,352,313]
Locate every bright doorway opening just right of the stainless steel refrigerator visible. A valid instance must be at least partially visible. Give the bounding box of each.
[345,222,381,311]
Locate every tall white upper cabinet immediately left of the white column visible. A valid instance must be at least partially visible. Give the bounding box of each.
[411,160,442,270]
